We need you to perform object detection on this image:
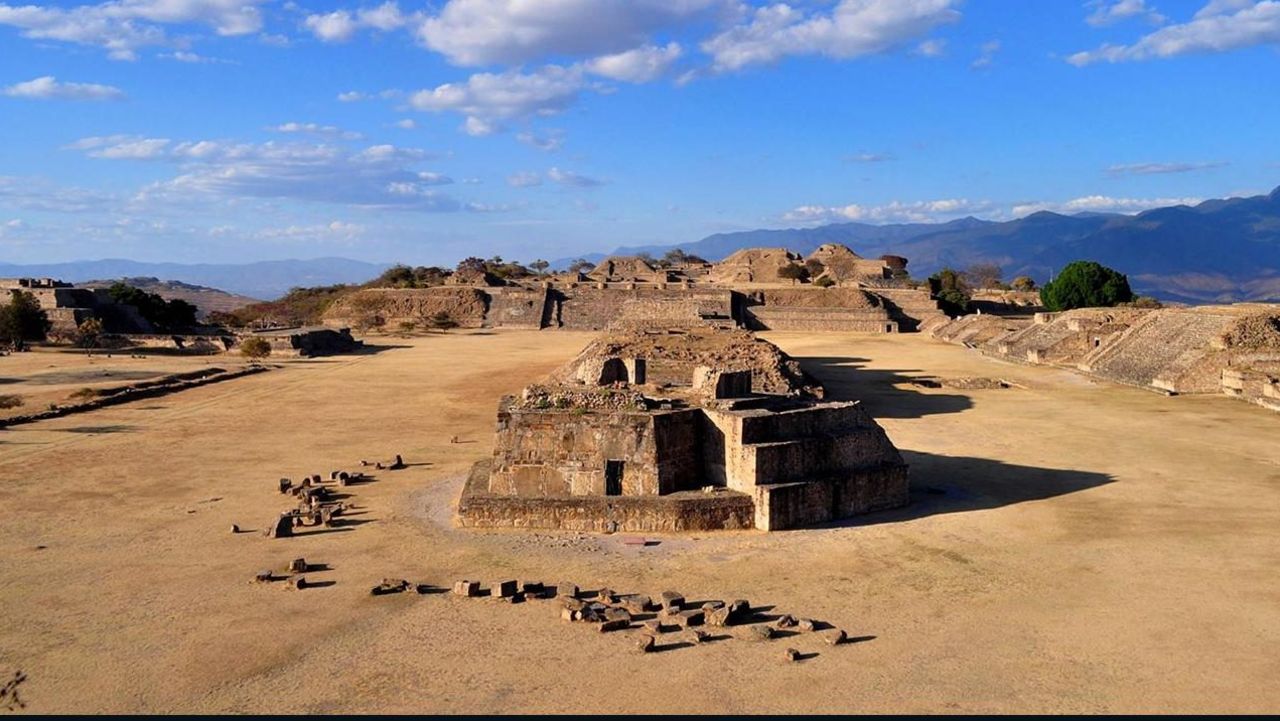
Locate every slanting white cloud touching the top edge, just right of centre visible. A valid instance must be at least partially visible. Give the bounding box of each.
[701,0,960,72]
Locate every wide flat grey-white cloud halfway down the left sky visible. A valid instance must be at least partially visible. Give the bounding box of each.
[70,136,460,211]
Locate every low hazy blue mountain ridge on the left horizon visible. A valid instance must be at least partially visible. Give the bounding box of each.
[0,257,389,300]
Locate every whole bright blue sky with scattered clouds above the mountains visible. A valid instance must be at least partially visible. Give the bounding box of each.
[0,0,1280,265]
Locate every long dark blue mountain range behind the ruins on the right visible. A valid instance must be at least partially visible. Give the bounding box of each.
[593,188,1280,302]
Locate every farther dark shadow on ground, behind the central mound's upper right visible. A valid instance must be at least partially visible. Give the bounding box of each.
[796,357,973,419]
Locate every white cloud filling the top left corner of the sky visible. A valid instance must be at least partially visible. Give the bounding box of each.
[0,0,266,60]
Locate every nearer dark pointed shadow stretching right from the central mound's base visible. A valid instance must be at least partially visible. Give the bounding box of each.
[824,451,1115,526]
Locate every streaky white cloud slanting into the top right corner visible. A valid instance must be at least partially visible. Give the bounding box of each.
[1066,0,1280,67]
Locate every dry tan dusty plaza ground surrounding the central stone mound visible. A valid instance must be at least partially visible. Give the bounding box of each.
[0,332,1280,713]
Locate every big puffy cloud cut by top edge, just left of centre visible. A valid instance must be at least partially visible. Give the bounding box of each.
[417,0,735,65]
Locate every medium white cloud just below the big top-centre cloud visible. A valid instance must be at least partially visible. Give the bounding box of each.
[408,65,586,136]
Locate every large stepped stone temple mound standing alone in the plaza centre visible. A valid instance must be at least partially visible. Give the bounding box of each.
[458,328,908,531]
